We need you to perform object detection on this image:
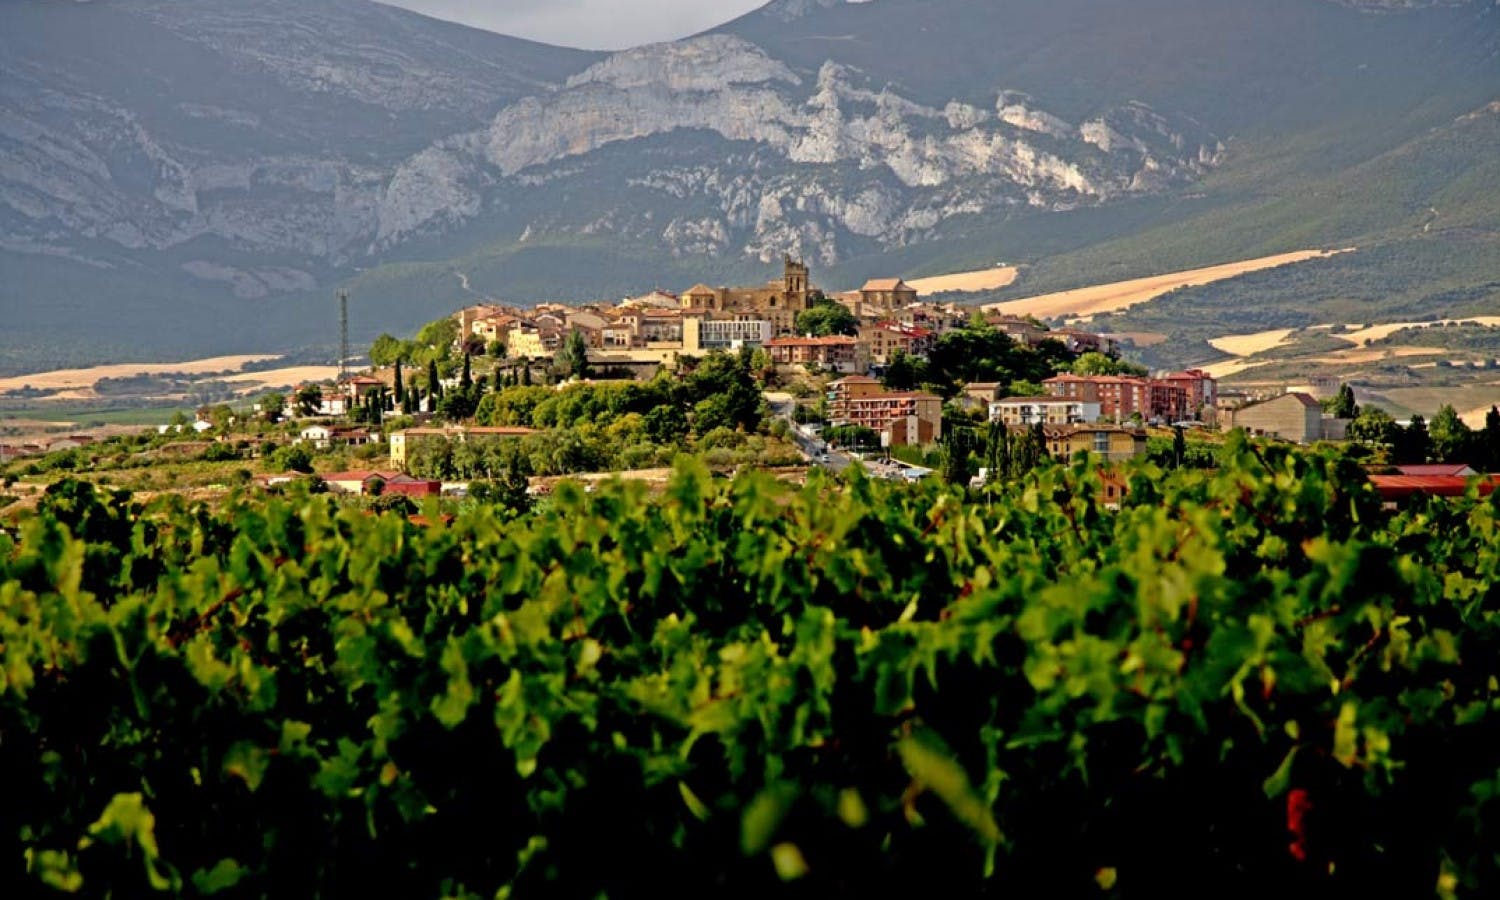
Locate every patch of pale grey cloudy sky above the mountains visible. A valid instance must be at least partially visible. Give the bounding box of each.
[383,0,767,50]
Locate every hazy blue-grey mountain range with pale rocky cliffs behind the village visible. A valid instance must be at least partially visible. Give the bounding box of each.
[0,0,1500,371]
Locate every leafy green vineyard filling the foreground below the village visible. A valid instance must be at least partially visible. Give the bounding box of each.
[0,438,1500,899]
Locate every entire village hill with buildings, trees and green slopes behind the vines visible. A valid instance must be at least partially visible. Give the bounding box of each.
[0,260,1500,512]
